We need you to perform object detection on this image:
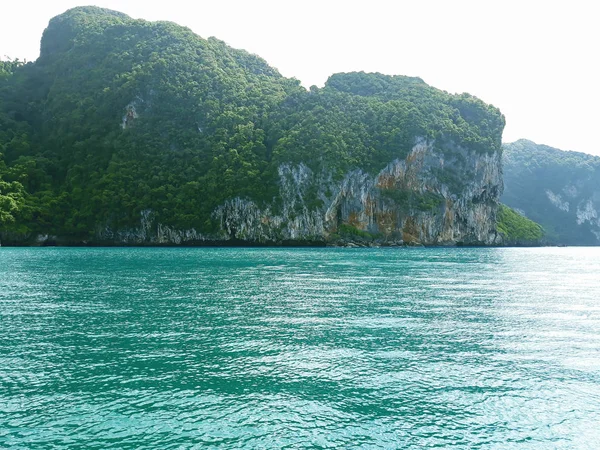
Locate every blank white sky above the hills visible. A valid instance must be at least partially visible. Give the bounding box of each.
[0,0,600,154]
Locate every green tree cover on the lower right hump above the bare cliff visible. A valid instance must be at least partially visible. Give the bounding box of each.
[271,72,504,178]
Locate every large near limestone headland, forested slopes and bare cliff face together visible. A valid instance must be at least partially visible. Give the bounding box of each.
[0,7,508,245]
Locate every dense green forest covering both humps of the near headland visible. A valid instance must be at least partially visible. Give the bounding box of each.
[0,7,504,239]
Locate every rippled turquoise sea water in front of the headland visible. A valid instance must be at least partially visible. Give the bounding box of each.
[0,248,600,449]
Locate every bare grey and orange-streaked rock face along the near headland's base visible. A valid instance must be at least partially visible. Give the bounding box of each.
[97,140,503,245]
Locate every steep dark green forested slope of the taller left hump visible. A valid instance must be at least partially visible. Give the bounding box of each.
[3,8,299,236]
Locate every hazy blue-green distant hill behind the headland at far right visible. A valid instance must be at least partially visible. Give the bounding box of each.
[502,140,600,245]
